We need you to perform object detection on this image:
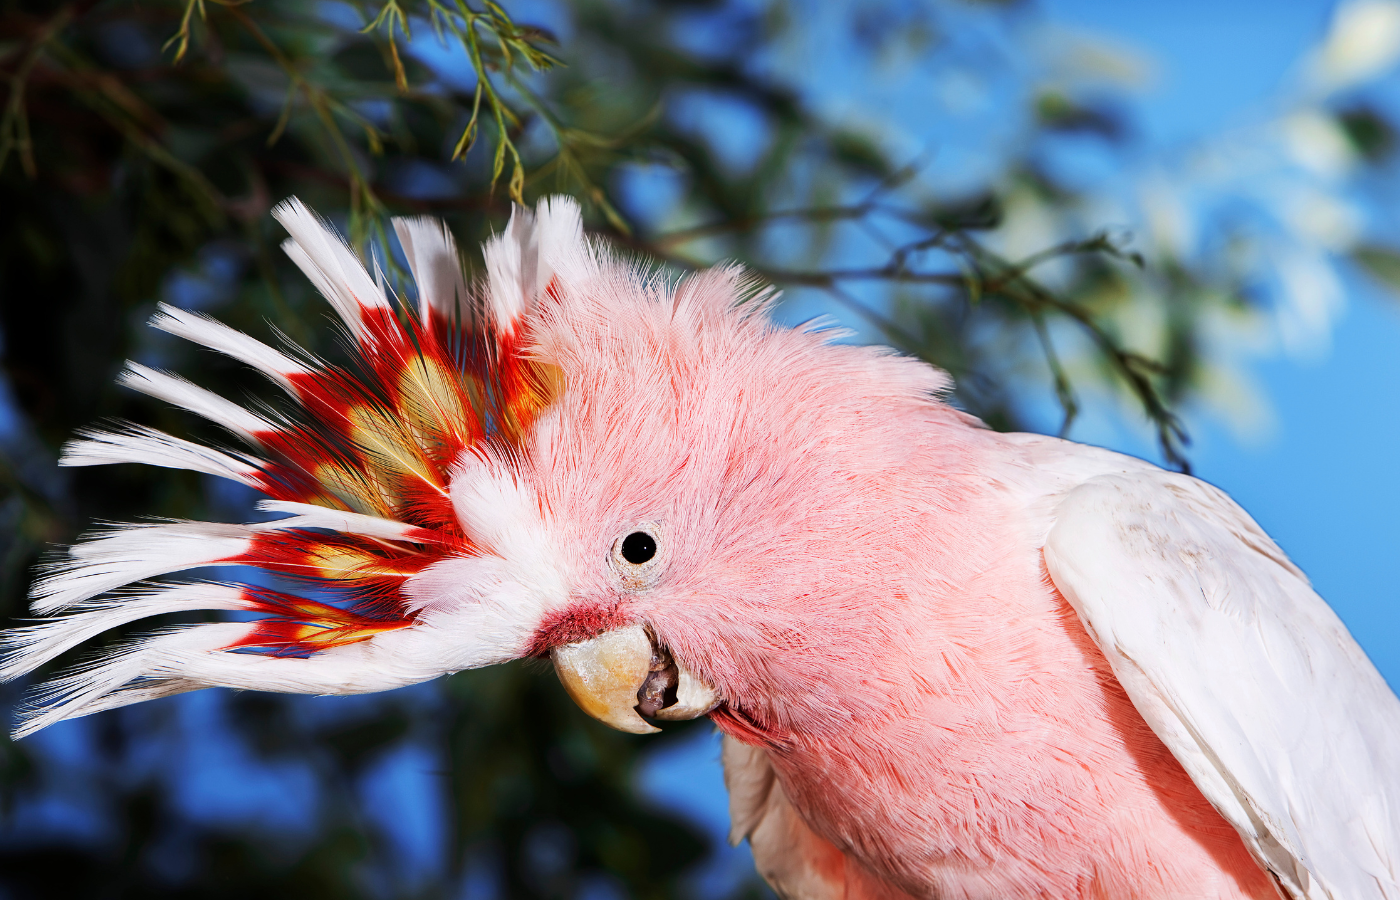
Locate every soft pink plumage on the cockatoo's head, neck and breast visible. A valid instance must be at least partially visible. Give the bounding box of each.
[509,250,1274,897]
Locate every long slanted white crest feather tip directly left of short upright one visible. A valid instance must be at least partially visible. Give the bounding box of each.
[272,197,389,339]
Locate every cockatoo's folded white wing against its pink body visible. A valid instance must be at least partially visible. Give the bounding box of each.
[1044,472,1400,900]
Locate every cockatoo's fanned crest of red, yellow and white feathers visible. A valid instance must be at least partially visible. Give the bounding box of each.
[0,199,591,733]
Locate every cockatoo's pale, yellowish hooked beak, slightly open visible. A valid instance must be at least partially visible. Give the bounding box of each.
[550,624,720,735]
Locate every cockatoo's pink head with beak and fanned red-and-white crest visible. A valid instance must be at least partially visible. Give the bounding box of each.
[0,199,956,740]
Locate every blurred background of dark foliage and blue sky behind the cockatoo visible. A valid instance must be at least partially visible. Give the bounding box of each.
[0,0,1400,900]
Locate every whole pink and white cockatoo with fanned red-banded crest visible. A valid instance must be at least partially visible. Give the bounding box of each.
[0,197,1400,900]
